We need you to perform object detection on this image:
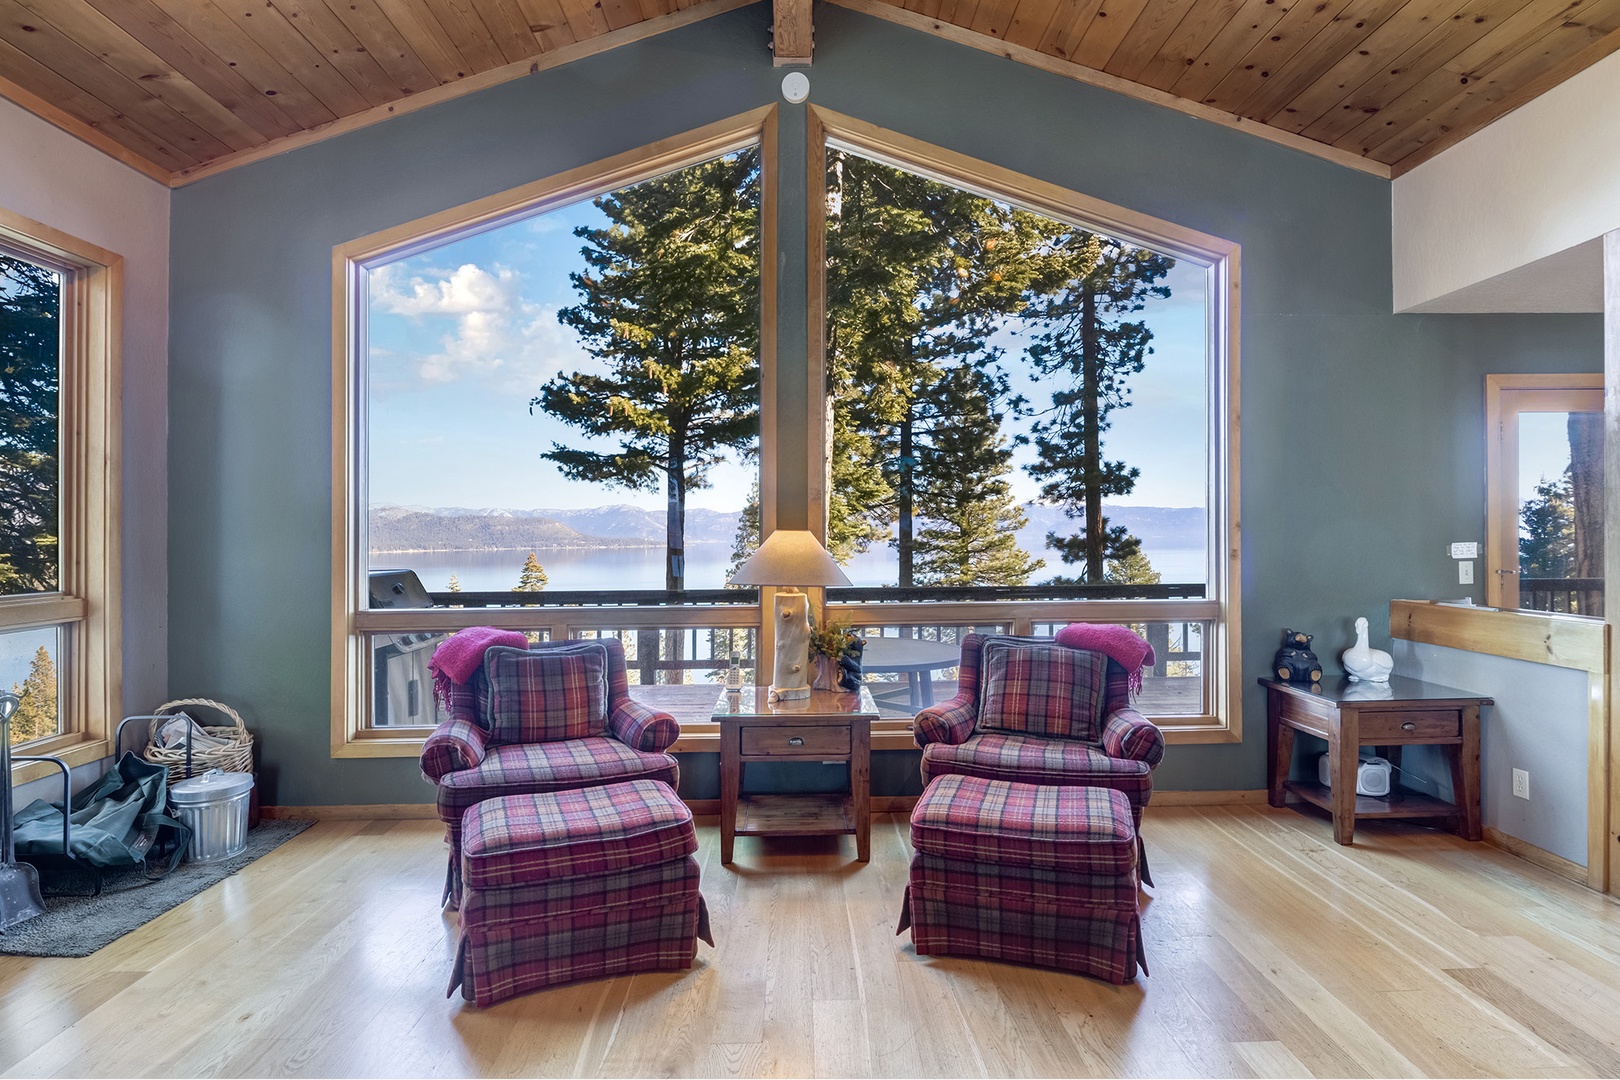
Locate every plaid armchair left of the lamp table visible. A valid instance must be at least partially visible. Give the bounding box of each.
[421,638,680,907]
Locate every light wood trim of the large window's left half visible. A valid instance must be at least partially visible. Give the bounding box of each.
[332,105,778,758]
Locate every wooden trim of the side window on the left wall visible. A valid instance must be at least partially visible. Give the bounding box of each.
[0,209,123,782]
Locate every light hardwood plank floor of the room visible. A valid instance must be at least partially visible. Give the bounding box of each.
[0,806,1620,1077]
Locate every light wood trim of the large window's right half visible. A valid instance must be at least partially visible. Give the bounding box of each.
[803,105,1243,743]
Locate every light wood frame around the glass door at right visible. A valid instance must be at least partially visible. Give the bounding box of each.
[1486,371,1604,619]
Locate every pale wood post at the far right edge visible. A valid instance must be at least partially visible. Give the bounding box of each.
[1592,230,1620,892]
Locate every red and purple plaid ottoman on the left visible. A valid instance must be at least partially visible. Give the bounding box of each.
[446,780,714,1006]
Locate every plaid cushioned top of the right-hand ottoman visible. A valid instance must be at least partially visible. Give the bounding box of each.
[910,776,1137,886]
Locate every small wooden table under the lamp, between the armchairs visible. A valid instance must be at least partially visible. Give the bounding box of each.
[714,687,878,865]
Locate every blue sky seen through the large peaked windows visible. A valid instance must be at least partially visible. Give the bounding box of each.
[368,178,1209,510]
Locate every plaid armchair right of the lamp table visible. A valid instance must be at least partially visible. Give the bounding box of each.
[915,633,1165,884]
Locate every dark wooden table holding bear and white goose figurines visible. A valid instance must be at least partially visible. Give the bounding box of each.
[1260,675,1492,844]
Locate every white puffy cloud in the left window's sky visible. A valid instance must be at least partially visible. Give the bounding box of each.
[371,262,595,393]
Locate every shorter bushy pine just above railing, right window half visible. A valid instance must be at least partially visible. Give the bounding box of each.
[914,366,1045,585]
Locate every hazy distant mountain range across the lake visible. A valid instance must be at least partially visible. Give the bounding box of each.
[371,504,1204,562]
